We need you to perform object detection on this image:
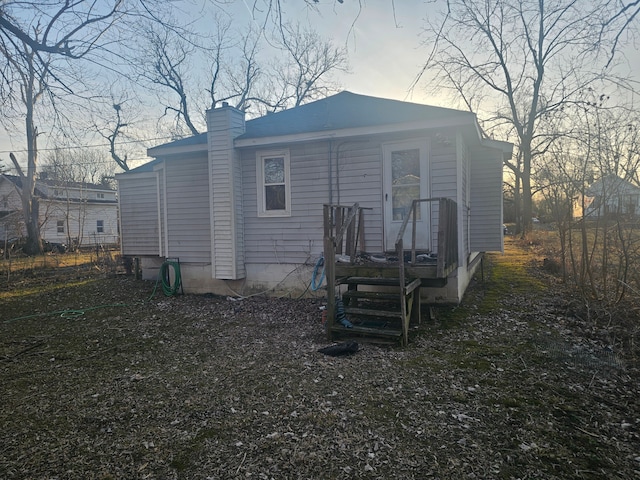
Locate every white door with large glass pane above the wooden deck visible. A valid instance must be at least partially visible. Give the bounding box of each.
[382,140,431,251]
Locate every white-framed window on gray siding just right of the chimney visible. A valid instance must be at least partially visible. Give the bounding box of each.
[257,151,291,217]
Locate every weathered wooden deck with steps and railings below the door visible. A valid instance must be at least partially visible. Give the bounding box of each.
[324,198,458,345]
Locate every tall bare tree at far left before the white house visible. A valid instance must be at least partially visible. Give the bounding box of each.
[0,0,182,253]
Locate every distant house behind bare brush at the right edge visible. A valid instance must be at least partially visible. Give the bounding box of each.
[584,175,640,218]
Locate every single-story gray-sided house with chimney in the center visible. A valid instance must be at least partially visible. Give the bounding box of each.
[116,91,512,303]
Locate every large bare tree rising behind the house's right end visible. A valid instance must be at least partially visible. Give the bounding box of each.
[419,0,616,231]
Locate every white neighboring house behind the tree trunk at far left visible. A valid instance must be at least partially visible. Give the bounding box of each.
[0,175,119,247]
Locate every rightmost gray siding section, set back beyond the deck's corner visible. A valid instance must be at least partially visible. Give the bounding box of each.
[470,147,503,252]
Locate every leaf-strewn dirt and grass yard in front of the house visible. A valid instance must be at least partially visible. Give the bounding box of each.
[0,242,640,480]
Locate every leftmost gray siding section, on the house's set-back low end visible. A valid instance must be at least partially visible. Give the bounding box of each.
[118,173,160,256]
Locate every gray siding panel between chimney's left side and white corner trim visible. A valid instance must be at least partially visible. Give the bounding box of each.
[161,156,211,263]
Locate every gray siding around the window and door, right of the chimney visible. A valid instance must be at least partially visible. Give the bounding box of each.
[242,133,470,263]
